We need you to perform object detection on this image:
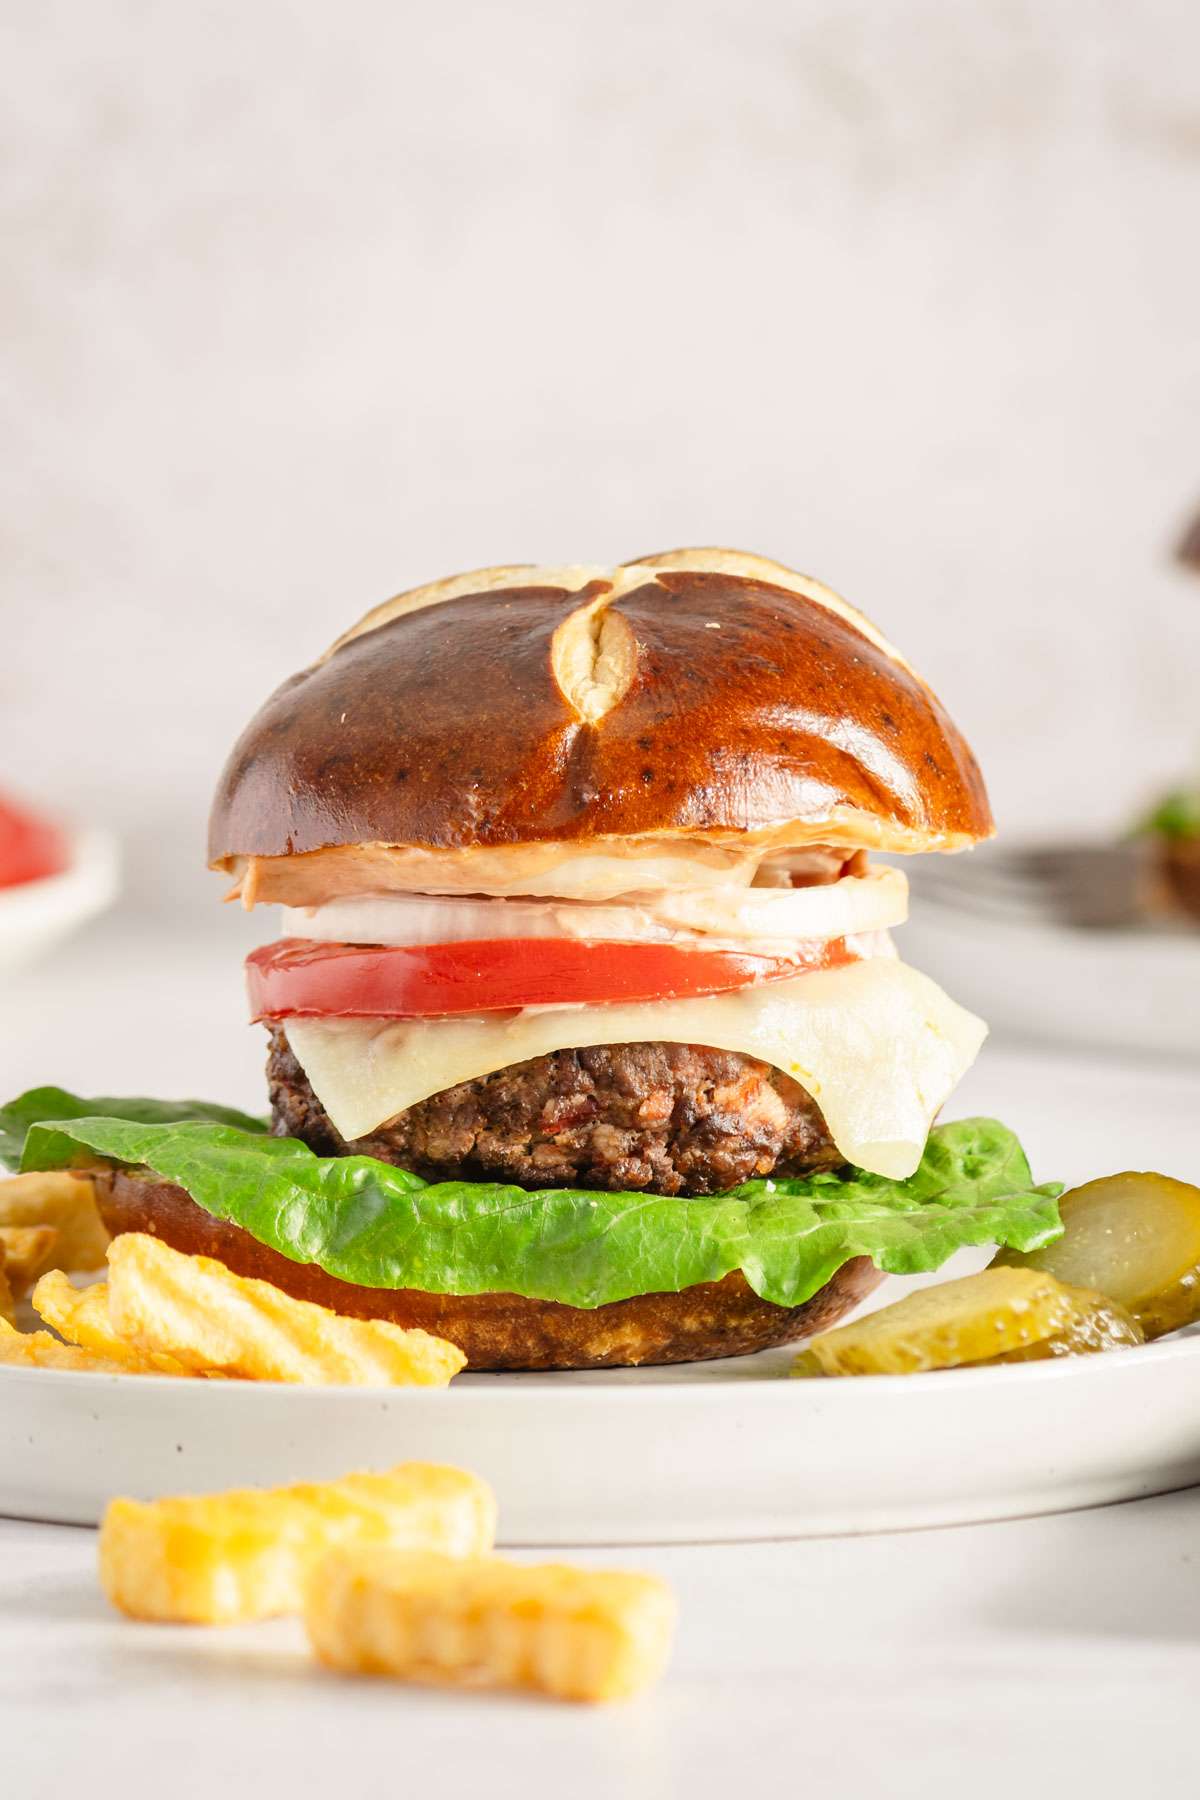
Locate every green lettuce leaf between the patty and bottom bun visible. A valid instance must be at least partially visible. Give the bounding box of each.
[0,1089,1061,1307]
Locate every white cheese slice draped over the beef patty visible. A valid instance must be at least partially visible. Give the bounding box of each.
[286,958,988,1179]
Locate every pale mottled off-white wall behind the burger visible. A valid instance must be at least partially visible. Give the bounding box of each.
[0,0,1200,911]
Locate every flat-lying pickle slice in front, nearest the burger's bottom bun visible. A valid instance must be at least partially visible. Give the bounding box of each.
[793,1265,1076,1375]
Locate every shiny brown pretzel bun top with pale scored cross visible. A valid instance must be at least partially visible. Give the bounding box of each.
[209,549,993,868]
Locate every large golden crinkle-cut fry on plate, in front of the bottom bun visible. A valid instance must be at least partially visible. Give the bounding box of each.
[108,1231,466,1388]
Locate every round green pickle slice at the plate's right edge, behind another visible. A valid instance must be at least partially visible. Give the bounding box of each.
[991,1170,1200,1337]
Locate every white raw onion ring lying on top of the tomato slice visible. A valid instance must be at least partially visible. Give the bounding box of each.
[282,868,909,954]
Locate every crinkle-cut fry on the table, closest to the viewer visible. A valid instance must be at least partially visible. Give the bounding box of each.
[304,1550,675,1701]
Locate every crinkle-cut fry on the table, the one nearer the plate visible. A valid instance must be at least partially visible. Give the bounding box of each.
[99,1463,497,1625]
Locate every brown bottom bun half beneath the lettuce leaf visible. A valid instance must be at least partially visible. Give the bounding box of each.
[95,1170,883,1368]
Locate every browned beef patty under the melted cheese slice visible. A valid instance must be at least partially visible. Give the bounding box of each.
[266,1026,844,1195]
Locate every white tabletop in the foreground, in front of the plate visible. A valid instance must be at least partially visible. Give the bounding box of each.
[0,1490,1200,1800]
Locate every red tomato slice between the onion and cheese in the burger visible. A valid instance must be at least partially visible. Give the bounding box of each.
[246,938,855,1021]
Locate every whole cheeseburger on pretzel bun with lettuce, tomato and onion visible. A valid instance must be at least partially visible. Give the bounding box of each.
[9,549,1056,1370]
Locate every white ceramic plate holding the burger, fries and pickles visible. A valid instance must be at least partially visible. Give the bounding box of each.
[0,1337,1200,1544]
